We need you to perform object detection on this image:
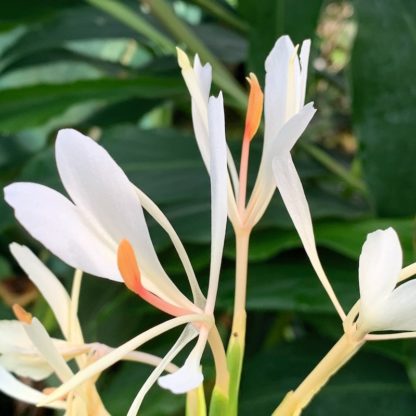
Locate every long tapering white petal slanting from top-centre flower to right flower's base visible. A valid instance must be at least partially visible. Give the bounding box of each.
[273,153,345,319]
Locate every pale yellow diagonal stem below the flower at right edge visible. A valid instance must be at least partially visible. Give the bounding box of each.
[273,334,365,416]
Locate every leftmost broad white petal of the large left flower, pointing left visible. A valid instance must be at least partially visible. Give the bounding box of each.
[4,182,118,281]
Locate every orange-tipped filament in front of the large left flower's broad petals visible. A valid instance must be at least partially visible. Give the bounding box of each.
[117,240,190,316]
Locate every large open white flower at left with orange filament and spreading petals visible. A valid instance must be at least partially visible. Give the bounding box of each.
[5,94,228,415]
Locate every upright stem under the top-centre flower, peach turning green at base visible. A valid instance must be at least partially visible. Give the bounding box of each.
[227,229,251,416]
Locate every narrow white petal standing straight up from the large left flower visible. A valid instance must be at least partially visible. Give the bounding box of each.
[207,93,227,313]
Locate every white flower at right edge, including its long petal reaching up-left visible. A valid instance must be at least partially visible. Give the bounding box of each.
[273,146,416,334]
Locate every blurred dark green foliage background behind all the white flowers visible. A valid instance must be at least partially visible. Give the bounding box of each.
[0,0,416,416]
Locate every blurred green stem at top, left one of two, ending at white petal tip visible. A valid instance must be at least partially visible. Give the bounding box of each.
[86,0,176,53]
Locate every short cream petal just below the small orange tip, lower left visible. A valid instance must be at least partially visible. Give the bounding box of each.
[24,318,73,382]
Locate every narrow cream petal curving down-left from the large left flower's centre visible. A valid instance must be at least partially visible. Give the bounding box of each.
[41,315,208,404]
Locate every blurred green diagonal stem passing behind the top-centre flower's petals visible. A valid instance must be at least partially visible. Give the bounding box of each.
[143,0,247,110]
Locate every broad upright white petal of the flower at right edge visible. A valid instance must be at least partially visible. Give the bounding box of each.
[359,228,403,327]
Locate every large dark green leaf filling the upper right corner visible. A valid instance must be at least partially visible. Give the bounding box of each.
[351,0,416,216]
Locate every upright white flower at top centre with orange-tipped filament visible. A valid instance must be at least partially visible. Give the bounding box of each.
[178,36,316,228]
